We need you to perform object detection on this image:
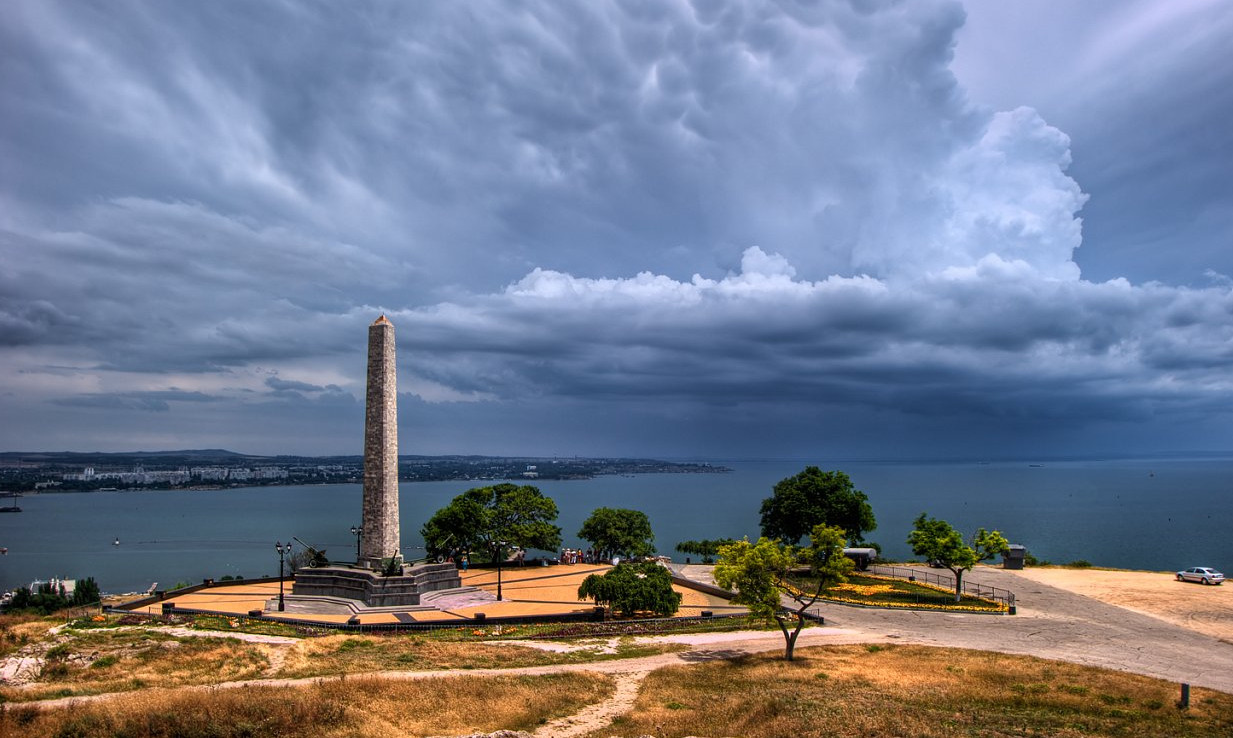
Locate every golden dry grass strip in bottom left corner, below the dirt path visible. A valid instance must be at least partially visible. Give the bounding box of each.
[0,674,613,738]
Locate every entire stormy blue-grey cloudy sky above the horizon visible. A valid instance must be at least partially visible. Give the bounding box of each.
[0,0,1233,461]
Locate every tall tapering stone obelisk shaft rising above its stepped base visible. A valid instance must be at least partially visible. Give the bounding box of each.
[356,315,402,569]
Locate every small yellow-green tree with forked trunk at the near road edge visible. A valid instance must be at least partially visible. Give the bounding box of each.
[715,525,852,662]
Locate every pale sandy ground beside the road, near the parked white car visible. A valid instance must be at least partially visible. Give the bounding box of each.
[1015,567,1233,643]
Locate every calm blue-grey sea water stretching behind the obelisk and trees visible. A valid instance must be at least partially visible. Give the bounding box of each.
[0,460,1233,591]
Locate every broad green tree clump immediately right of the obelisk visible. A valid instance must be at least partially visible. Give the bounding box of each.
[419,483,561,558]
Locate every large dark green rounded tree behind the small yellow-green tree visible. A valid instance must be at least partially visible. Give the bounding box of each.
[762,467,878,545]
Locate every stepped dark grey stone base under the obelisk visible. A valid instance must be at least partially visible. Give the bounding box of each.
[291,563,462,607]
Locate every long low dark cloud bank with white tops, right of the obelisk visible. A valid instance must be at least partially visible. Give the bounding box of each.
[395,248,1233,416]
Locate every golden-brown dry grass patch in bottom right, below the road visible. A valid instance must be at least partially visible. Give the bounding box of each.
[594,646,1233,738]
